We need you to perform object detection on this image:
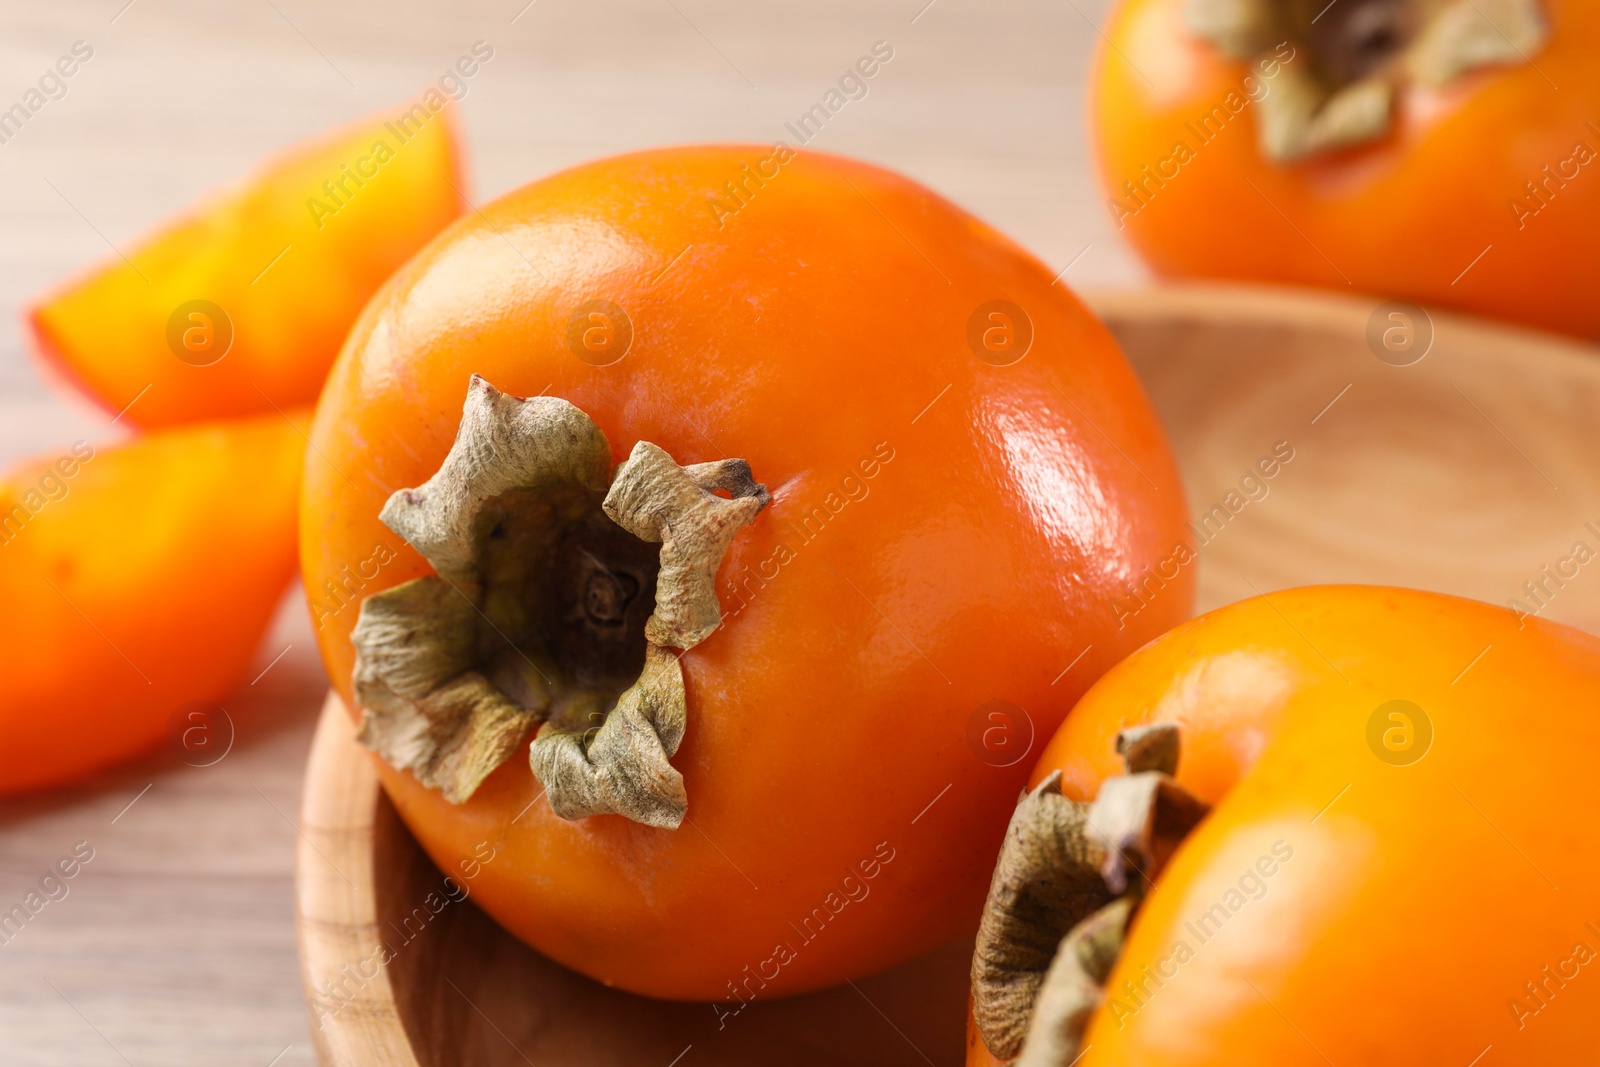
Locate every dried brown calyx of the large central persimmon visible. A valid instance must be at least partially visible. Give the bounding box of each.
[350,376,770,827]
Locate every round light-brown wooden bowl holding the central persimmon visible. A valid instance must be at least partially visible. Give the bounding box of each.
[298,279,1600,1067]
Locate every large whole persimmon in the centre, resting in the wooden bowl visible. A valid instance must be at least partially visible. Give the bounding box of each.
[301,144,1194,1017]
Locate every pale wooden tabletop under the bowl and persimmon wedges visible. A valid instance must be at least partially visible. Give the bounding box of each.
[0,0,1141,1067]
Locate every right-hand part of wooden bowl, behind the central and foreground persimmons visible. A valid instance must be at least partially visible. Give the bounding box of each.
[1090,286,1600,632]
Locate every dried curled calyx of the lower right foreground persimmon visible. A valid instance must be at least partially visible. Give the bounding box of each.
[973,723,1208,1067]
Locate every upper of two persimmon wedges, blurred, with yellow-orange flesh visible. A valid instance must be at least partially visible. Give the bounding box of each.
[27,102,464,427]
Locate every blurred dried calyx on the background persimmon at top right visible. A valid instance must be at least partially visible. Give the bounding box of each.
[1184,0,1549,160]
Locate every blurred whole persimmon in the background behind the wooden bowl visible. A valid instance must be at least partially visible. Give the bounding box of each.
[1091,0,1600,338]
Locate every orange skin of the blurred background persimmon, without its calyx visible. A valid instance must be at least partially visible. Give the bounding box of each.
[1091,0,1600,339]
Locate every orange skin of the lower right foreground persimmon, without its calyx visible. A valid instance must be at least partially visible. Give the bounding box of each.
[968,585,1600,1067]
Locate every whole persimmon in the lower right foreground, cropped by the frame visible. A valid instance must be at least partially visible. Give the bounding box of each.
[968,585,1600,1067]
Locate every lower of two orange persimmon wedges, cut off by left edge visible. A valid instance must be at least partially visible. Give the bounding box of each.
[0,411,307,793]
